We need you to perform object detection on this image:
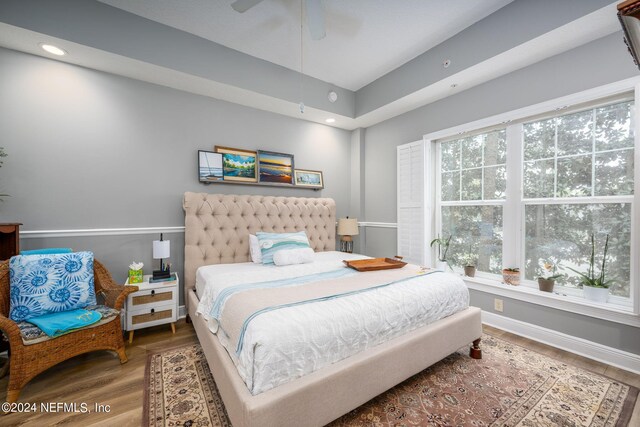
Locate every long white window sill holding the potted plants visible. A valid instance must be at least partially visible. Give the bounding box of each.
[462,277,640,327]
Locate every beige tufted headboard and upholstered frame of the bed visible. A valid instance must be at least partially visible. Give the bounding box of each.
[183,193,482,427]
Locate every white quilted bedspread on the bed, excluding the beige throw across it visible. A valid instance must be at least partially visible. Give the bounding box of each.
[196,252,469,395]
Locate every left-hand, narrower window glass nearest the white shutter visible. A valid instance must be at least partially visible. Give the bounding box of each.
[440,129,507,273]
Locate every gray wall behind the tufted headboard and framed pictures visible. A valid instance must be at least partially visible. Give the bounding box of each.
[0,49,351,304]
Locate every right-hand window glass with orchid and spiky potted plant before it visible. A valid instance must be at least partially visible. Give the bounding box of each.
[522,101,634,298]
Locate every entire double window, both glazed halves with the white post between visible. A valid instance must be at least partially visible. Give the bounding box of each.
[435,96,637,306]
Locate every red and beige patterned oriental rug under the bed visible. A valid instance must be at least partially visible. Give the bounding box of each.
[144,334,638,427]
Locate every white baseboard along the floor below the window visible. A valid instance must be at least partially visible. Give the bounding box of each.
[482,310,640,374]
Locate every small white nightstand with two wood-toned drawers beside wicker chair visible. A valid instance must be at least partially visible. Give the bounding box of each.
[125,273,180,344]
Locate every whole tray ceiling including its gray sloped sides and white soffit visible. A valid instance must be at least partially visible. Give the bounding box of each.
[0,0,624,130]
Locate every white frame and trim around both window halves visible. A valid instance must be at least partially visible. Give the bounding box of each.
[423,77,640,326]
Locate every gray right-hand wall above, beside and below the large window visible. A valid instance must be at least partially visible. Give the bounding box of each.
[364,32,640,353]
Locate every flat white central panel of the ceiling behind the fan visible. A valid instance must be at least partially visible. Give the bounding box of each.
[100,0,513,91]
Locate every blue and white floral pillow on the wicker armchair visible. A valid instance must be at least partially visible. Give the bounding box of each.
[9,252,96,322]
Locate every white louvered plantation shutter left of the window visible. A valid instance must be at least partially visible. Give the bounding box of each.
[396,141,427,265]
